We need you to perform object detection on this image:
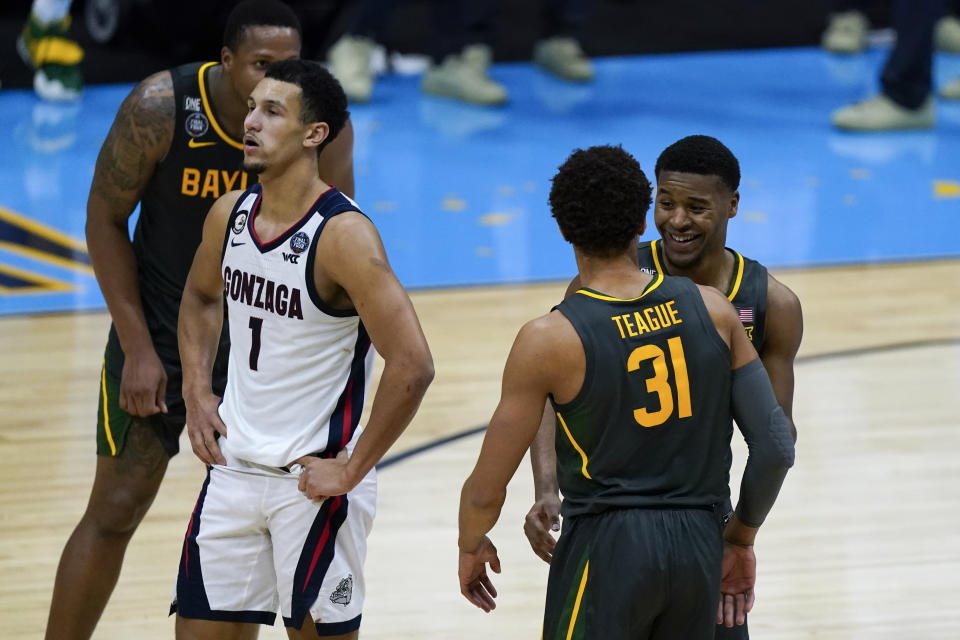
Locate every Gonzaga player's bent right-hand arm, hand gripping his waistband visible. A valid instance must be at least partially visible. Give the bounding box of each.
[291,211,433,500]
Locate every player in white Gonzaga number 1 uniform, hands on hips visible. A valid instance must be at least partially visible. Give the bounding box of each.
[171,60,433,639]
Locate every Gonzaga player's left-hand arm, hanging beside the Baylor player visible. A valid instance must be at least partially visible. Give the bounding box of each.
[177,191,243,464]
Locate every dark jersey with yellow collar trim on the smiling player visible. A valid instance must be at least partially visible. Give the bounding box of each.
[637,240,769,353]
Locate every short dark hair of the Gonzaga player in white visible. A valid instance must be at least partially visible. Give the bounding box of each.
[264,58,350,153]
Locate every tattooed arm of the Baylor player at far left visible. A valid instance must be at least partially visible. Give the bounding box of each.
[86,71,176,416]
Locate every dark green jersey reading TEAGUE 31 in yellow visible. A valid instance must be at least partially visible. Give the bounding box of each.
[551,274,733,517]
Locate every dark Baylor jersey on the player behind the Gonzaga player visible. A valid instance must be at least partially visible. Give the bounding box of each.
[133,62,256,348]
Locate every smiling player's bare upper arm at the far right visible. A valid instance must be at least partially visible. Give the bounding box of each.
[760,276,803,440]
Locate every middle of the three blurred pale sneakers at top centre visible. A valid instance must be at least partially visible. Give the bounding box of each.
[420,44,507,106]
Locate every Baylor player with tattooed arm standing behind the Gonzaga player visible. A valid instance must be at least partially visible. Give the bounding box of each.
[47,0,353,640]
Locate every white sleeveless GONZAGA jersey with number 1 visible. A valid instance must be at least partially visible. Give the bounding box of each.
[220,184,374,467]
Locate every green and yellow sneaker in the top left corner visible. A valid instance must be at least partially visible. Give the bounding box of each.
[17,14,83,101]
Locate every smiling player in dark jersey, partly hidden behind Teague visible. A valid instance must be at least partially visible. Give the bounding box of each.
[524,135,803,640]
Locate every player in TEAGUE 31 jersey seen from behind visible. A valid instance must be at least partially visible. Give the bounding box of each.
[459,147,794,640]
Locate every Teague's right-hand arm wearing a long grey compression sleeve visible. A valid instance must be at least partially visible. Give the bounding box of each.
[697,285,794,627]
